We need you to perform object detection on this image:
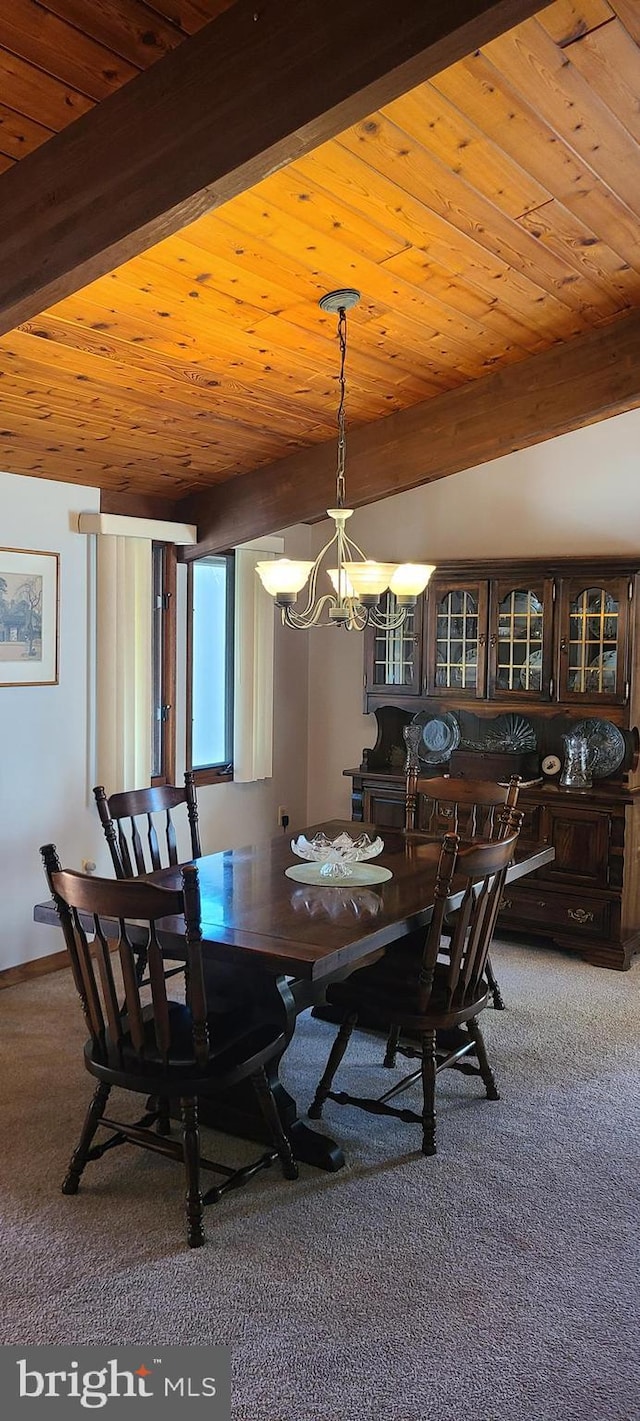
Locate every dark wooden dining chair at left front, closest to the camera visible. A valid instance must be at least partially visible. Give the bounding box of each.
[41,844,297,1248]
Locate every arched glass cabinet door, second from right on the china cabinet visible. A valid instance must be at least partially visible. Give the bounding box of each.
[489,578,553,701]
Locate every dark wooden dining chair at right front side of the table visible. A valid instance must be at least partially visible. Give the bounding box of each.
[309,833,518,1155]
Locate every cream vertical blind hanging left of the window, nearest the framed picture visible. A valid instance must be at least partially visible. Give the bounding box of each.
[95,536,152,794]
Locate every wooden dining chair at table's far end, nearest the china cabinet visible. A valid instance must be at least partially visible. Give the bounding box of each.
[404,769,522,1012]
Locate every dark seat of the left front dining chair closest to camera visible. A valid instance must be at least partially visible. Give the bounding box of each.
[85,1002,286,1096]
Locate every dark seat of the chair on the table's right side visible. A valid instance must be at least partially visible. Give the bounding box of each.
[327,949,489,1032]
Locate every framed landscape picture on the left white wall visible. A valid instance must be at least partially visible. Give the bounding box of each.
[0,547,58,686]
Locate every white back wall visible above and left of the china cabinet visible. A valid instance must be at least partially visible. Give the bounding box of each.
[309,409,640,820]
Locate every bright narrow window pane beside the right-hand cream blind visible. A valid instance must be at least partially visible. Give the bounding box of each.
[186,553,233,783]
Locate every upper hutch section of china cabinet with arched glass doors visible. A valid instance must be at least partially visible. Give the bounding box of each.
[364,558,640,711]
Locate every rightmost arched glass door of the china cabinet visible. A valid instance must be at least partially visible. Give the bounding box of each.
[560,577,629,702]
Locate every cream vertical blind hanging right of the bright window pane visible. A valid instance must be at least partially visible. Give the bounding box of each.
[233,537,284,784]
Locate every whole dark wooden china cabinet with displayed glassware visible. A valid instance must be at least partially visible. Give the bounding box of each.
[352,557,640,969]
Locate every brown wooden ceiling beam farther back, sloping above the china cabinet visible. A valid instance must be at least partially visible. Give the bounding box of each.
[176,311,640,558]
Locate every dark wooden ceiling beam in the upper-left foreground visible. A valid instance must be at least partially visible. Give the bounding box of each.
[0,0,539,334]
